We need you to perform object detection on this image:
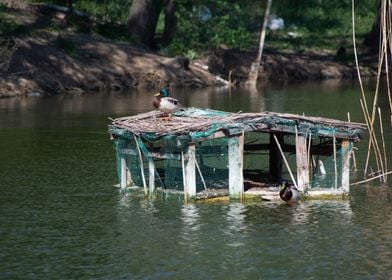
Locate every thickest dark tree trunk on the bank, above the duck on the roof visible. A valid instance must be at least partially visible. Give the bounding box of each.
[128,0,163,47]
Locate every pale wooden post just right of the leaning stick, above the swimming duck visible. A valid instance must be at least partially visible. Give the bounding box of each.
[295,133,310,192]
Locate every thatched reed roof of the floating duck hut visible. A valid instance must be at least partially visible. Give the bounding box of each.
[109,108,366,142]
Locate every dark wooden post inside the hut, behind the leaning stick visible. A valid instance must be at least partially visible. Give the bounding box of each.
[269,133,284,183]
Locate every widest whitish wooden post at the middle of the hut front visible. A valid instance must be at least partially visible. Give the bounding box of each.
[228,134,244,198]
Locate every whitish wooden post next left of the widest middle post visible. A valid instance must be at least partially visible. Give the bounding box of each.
[183,143,196,197]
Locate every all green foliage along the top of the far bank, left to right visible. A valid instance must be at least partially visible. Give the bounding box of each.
[14,0,377,54]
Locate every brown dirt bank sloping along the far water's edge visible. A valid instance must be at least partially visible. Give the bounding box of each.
[0,2,375,97]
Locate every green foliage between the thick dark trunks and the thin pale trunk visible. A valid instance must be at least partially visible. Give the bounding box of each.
[169,1,254,54]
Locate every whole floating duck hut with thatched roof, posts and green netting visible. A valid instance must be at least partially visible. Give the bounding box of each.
[109,108,364,201]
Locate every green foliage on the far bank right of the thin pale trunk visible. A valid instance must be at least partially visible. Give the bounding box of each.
[267,0,377,50]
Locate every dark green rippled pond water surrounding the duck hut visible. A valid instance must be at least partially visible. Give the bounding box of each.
[0,83,392,279]
